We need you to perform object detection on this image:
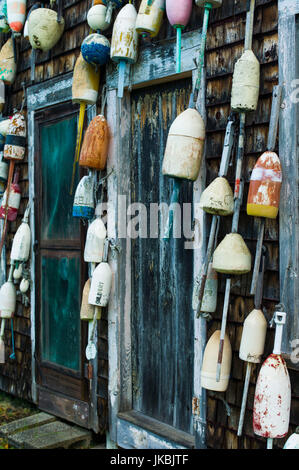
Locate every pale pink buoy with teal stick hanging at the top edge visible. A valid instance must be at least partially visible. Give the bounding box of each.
[166,0,192,73]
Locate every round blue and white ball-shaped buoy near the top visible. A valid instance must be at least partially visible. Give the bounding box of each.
[81,33,110,65]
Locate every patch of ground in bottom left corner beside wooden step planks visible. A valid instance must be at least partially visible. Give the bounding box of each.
[0,392,38,449]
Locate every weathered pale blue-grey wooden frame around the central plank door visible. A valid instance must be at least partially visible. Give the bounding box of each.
[106,31,206,449]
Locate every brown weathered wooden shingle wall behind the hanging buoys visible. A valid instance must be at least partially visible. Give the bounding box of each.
[0,0,299,449]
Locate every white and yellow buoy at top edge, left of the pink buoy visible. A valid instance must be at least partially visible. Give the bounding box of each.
[136,0,165,38]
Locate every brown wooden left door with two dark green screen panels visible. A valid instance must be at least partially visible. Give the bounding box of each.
[35,103,89,427]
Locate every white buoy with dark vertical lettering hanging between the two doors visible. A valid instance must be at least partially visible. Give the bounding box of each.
[88,262,112,307]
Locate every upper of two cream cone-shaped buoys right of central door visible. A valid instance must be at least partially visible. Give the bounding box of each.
[200,177,234,216]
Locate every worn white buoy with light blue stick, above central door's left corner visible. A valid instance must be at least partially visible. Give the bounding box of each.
[111,3,138,98]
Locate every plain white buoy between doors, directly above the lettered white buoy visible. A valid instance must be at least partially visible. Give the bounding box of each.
[84,217,107,263]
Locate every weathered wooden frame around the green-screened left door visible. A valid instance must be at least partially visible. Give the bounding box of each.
[27,73,99,432]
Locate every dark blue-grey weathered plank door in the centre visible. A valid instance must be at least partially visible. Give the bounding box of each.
[131,79,194,433]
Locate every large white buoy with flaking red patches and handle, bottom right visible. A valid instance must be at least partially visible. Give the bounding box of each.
[253,312,291,449]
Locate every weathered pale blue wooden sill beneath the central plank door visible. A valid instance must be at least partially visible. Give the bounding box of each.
[117,410,195,449]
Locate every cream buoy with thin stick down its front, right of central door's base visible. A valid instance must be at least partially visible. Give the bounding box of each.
[201,330,232,392]
